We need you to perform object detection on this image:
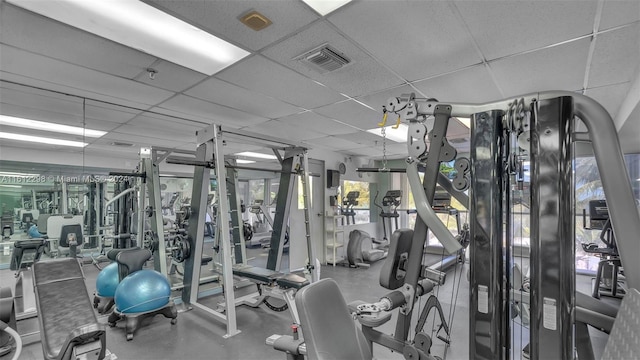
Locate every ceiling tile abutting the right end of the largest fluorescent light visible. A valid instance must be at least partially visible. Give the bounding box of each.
[216,56,344,109]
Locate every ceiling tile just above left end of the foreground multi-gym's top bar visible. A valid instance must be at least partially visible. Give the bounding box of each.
[413,64,502,103]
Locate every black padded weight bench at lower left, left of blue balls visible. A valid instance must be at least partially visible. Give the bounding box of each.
[33,258,106,360]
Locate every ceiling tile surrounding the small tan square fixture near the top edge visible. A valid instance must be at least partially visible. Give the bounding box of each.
[146,0,319,50]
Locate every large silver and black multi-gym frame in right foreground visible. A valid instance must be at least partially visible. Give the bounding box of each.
[380,91,640,359]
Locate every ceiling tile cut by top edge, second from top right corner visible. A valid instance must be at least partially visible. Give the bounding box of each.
[454,0,598,60]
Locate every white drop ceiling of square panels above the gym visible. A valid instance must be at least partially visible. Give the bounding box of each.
[0,0,640,170]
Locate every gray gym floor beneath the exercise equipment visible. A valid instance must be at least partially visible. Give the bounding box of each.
[0,249,607,360]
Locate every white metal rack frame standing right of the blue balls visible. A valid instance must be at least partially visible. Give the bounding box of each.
[179,124,318,338]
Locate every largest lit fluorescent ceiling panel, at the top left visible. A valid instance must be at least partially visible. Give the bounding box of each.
[8,0,249,75]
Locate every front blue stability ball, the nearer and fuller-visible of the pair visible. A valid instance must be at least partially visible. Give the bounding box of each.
[115,269,171,314]
